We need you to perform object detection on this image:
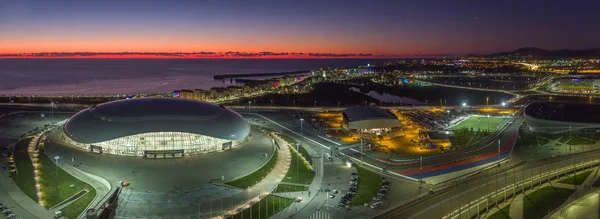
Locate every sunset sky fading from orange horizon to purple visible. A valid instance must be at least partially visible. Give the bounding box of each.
[0,0,600,55]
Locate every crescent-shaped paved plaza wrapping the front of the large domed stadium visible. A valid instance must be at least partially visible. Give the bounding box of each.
[46,126,273,190]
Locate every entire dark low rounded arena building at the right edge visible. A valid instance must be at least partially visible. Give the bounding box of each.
[525,102,600,134]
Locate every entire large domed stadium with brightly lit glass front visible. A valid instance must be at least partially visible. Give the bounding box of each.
[60,98,250,158]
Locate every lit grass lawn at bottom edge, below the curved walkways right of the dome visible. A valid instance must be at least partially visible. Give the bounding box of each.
[229,195,294,219]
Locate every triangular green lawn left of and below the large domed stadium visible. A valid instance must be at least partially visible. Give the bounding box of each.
[38,153,95,211]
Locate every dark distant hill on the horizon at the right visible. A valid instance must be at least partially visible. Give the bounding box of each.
[485,47,600,59]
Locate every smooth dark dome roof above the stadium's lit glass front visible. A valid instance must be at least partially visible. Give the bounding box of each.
[63,98,250,144]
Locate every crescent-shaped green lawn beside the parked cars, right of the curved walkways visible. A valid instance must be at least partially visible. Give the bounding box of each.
[352,166,382,206]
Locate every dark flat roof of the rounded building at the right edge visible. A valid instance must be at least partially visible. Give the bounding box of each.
[525,102,600,123]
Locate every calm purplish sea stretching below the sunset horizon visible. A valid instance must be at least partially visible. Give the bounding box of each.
[0,58,398,95]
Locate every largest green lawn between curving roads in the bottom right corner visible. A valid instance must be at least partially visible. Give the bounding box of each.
[523,186,573,219]
